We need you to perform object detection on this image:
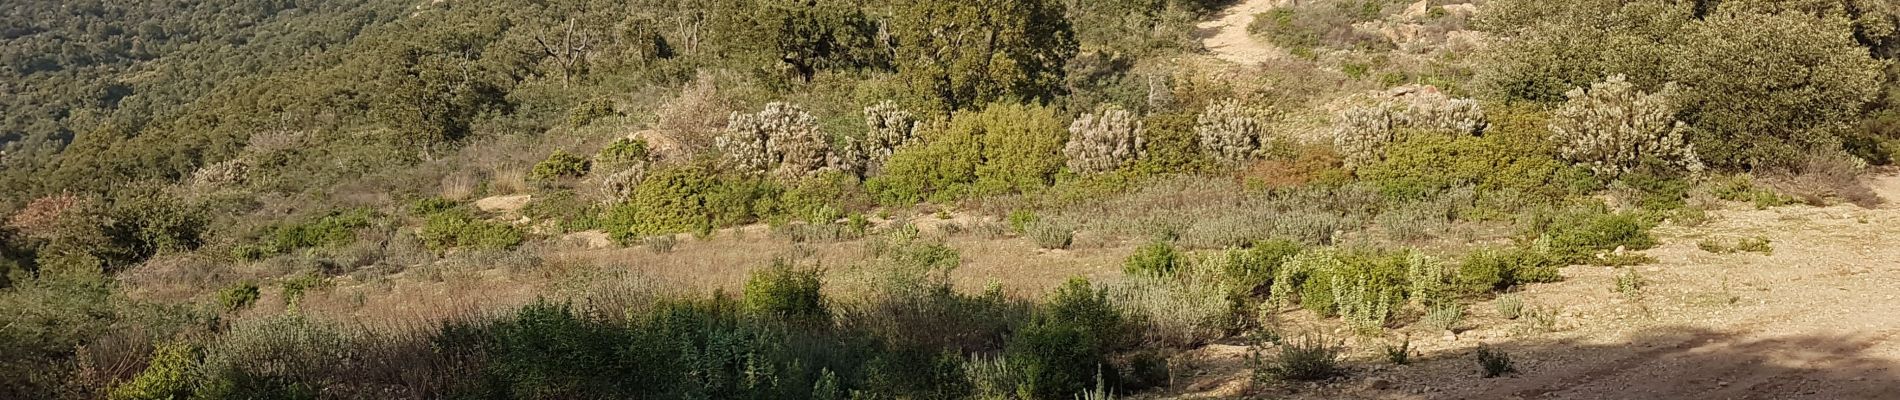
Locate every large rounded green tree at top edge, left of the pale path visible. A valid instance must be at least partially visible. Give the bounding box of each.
[891,0,1077,110]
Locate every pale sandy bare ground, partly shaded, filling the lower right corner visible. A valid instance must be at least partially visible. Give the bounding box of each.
[1167,171,1900,400]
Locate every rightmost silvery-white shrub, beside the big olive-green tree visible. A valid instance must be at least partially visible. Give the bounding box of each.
[1550,74,1702,176]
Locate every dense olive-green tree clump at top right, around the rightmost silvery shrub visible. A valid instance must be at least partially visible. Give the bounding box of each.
[1480,0,1879,169]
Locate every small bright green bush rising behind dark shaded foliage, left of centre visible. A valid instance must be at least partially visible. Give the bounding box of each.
[745,262,827,320]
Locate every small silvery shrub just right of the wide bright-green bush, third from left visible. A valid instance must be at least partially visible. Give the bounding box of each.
[1062,106,1146,173]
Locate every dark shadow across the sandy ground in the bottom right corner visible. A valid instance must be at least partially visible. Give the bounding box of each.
[1413,326,1900,400]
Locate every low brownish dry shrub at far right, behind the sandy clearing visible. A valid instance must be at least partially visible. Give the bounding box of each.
[1763,152,1881,209]
